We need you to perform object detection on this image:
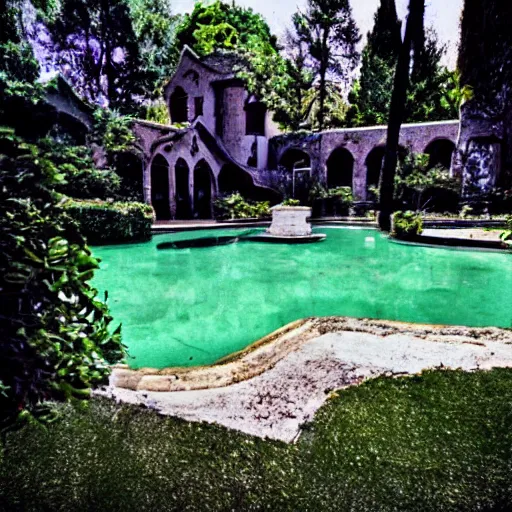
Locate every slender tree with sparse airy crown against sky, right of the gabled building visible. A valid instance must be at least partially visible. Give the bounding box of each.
[293,0,360,130]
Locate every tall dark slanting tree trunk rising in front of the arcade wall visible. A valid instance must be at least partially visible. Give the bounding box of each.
[379,0,425,231]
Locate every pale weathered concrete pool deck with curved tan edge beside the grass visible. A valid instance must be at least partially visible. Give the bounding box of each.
[98,317,512,442]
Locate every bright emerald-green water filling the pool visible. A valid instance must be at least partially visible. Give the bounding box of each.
[94,228,512,368]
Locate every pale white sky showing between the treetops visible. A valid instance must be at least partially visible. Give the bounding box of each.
[171,0,463,67]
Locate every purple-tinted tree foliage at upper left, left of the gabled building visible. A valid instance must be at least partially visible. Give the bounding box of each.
[37,0,177,115]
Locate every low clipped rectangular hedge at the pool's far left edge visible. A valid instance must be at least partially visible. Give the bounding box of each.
[63,199,153,245]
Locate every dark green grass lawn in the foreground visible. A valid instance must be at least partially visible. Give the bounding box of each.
[0,369,512,512]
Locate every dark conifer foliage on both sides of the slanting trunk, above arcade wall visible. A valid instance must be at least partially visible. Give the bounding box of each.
[346,0,465,126]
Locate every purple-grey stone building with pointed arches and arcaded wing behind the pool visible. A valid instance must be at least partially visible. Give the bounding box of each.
[134,47,459,219]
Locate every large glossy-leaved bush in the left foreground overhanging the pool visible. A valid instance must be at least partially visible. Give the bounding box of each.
[0,128,123,425]
